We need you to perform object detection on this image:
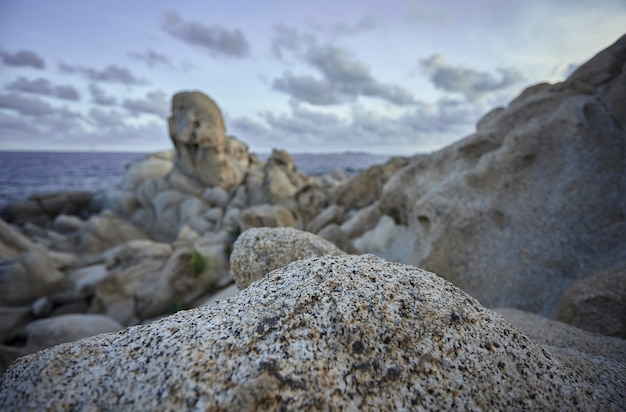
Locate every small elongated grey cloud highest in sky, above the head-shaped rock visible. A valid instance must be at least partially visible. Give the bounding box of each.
[161,11,250,57]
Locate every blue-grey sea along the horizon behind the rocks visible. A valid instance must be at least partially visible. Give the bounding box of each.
[0,151,391,211]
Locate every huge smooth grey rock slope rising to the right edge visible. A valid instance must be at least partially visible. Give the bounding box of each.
[372,36,626,317]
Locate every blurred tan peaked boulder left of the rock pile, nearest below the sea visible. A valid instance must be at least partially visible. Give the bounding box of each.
[78,210,147,253]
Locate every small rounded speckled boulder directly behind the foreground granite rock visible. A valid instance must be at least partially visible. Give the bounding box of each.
[230,228,345,290]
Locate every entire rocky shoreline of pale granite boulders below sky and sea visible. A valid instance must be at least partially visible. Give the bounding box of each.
[0,33,626,410]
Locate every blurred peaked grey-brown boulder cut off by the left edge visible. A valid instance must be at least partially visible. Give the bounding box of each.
[0,245,65,306]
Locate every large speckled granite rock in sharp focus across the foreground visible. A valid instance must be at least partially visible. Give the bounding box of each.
[0,255,623,411]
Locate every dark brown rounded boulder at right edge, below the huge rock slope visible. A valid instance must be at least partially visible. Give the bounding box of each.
[557,263,626,339]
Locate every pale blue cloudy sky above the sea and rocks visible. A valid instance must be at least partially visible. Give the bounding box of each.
[0,0,626,154]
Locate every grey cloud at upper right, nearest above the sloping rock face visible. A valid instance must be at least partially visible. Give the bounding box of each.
[420,54,524,101]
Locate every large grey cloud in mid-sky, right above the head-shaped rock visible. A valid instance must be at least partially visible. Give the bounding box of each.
[272,43,415,106]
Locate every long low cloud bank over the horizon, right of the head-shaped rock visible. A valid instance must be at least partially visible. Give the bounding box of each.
[227,99,483,154]
